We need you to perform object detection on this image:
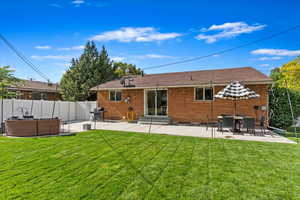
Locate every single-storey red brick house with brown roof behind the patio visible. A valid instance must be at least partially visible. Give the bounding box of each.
[92,67,272,123]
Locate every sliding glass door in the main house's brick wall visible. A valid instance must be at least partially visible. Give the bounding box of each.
[145,90,168,116]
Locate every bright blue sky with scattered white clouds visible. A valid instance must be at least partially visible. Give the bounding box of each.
[0,0,300,82]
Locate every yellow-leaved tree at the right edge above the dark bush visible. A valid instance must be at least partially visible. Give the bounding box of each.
[271,57,300,91]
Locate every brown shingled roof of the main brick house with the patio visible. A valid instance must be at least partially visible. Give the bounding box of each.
[92,67,272,90]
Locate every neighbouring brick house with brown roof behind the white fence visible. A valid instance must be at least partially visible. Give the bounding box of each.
[9,80,60,101]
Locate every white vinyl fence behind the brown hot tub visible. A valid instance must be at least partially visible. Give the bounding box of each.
[0,99,97,121]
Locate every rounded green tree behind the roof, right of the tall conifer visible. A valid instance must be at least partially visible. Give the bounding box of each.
[113,62,143,78]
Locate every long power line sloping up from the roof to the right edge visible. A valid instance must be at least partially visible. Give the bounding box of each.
[143,25,300,70]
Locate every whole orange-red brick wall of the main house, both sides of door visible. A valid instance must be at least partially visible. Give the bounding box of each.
[98,85,268,122]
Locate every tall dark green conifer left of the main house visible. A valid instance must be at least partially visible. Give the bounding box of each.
[60,42,114,101]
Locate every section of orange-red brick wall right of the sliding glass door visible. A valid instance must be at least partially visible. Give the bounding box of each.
[168,85,268,122]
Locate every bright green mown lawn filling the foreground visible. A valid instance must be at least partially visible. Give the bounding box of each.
[0,131,300,200]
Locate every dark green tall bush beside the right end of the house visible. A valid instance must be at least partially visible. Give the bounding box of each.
[269,87,300,129]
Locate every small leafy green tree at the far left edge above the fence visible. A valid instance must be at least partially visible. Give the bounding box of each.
[0,66,22,99]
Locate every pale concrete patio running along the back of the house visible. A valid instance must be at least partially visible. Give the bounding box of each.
[61,121,295,144]
